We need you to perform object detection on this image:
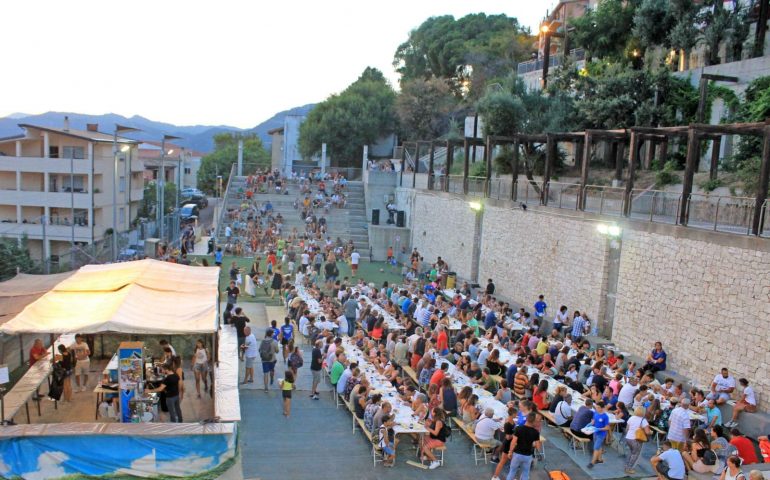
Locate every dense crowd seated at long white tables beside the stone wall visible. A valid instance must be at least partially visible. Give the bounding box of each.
[250,250,770,480]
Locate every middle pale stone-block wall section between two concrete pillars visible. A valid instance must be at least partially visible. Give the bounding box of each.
[479,205,608,322]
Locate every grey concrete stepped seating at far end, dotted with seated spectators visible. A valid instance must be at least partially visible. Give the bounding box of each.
[217,177,370,260]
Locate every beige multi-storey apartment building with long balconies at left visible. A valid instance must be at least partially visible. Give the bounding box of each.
[0,117,144,261]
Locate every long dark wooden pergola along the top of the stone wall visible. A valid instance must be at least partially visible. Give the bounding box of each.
[402,119,770,235]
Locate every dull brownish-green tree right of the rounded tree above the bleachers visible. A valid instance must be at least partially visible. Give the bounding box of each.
[396,78,456,140]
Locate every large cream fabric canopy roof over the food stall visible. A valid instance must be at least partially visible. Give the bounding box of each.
[0,260,219,335]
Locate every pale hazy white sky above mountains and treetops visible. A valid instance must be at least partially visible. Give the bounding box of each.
[0,0,556,128]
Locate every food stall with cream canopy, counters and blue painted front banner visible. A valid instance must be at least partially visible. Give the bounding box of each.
[0,260,240,478]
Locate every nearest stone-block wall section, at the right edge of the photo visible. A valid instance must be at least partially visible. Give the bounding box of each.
[612,230,770,411]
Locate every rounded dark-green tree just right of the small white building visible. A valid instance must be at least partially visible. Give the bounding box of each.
[299,67,398,167]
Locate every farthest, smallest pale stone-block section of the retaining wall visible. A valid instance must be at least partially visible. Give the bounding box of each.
[409,192,476,278]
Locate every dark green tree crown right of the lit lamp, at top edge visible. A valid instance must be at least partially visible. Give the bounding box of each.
[571,0,639,58]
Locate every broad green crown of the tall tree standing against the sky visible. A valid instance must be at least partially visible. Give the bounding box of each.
[393,13,532,98]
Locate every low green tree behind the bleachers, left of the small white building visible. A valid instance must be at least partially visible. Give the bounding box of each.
[198,133,270,194]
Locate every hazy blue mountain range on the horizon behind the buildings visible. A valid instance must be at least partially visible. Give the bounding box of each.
[0,103,315,153]
